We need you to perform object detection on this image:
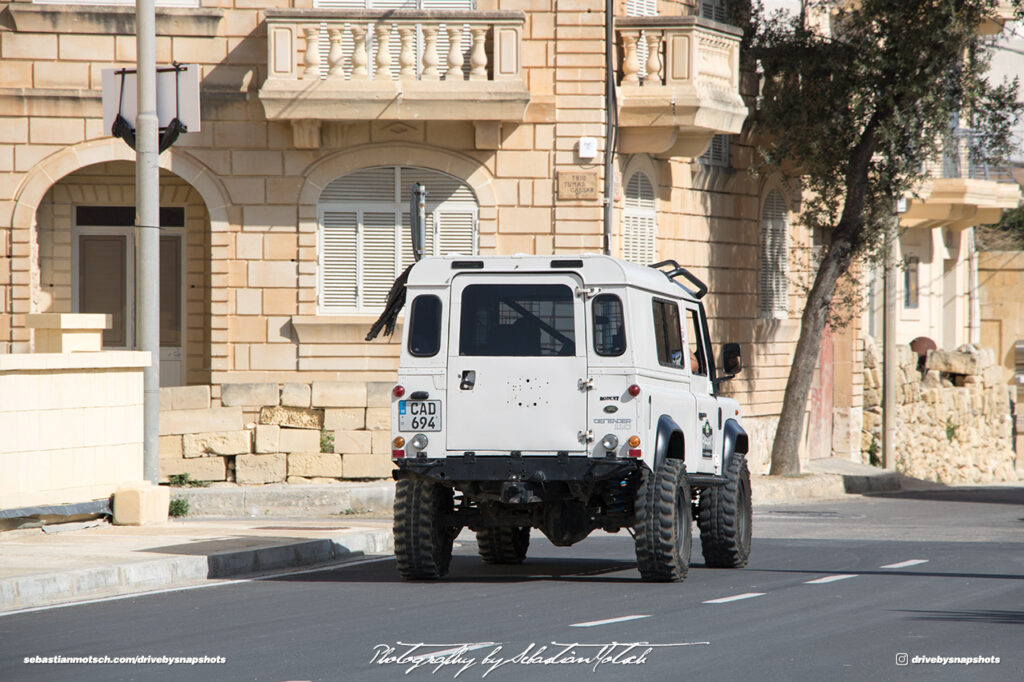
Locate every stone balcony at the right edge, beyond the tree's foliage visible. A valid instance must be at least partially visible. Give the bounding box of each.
[900,128,1021,229]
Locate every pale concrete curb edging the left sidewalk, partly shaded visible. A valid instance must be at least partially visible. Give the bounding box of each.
[0,528,394,613]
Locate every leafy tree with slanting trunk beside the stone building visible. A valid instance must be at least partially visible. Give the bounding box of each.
[745,0,1024,474]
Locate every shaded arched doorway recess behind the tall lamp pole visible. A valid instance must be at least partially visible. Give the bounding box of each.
[34,161,210,386]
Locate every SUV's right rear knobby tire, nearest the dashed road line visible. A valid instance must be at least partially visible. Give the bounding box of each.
[634,460,693,583]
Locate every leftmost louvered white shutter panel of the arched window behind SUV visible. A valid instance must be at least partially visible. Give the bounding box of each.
[318,211,358,309]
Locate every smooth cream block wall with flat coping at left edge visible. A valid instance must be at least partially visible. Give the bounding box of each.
[0,351,150,509]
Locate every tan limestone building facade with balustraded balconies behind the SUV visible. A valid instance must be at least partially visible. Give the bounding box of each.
[0,0,1015,489]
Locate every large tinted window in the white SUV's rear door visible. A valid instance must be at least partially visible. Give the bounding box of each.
[459,285,575,357]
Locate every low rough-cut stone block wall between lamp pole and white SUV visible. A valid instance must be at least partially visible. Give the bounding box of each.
[160,381,394,485]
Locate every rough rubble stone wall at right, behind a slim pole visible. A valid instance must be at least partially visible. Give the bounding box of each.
[861,338,1020,485]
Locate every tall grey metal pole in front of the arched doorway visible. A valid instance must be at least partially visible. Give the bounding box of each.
[135,0,160,484]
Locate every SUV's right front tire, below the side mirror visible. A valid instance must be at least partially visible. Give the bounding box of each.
[697,454,753,568]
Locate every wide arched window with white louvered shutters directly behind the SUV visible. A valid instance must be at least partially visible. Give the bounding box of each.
[317,166,478,313]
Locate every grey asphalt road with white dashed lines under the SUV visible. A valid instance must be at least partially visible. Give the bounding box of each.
[0,487,1024,681]
